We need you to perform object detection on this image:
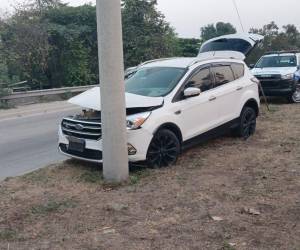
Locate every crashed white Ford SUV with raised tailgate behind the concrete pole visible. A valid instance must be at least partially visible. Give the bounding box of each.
[59,34,262,167]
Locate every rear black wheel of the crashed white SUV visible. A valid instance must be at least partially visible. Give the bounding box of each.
[234,106,256,140]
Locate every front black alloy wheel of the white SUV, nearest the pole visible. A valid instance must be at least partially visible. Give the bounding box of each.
[147,129,180,168]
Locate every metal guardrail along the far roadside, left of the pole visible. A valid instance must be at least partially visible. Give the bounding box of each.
[0,85,99,101]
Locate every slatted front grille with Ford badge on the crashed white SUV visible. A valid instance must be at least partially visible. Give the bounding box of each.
[61,118,102,140]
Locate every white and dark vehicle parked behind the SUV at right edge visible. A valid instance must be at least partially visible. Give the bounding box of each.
[252,51,300,102]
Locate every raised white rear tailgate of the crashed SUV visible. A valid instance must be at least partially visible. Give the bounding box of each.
[198,33,264,59]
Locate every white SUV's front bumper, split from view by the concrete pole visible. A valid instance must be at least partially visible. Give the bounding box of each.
[58,126,153,163]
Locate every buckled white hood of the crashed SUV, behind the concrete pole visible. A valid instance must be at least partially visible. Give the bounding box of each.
[68,87,164,111]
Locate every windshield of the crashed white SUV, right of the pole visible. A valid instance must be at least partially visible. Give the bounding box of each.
[125,67,186,97]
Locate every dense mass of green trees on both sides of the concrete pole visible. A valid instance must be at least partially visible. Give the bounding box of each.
[0,0,179,89]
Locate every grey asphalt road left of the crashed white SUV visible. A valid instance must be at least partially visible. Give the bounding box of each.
[0,102,80,180]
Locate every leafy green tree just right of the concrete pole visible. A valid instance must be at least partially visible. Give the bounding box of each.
[122,0,177,67]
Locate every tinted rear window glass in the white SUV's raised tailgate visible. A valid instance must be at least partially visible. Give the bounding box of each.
[200,39,252,54]
